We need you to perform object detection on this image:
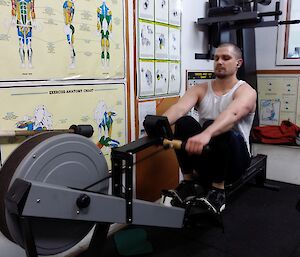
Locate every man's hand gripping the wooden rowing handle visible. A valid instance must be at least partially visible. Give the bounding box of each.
[185,131,211,154]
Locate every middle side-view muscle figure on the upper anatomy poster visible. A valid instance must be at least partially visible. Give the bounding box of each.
[63,0,75,68]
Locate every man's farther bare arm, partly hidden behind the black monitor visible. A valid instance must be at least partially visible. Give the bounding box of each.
[163,85,206,125]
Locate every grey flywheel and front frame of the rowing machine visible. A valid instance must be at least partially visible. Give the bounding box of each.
[0,117,192,254]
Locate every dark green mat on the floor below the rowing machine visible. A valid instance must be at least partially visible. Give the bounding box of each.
[114,228,153,256]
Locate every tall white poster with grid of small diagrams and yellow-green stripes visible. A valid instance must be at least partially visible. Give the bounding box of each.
[137,0,181,99]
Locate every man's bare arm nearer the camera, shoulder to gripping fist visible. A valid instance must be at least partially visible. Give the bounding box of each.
[186,84,256,154]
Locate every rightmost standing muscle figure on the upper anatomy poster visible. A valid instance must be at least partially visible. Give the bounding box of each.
[97,1,112,65]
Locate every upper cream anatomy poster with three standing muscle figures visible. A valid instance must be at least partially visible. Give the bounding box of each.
[0,0,125,81]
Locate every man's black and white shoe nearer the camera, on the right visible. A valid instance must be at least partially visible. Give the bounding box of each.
[199,188,226,214]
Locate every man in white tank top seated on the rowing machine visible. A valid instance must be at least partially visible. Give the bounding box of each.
[164,43,256,213]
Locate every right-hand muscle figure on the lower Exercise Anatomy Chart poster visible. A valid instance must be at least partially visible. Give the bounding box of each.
[94,101,120,149]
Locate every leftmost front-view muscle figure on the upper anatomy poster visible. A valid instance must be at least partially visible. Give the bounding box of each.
[11,0,35,68]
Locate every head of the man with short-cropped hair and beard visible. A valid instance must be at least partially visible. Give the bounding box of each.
[214,43,243,79]
